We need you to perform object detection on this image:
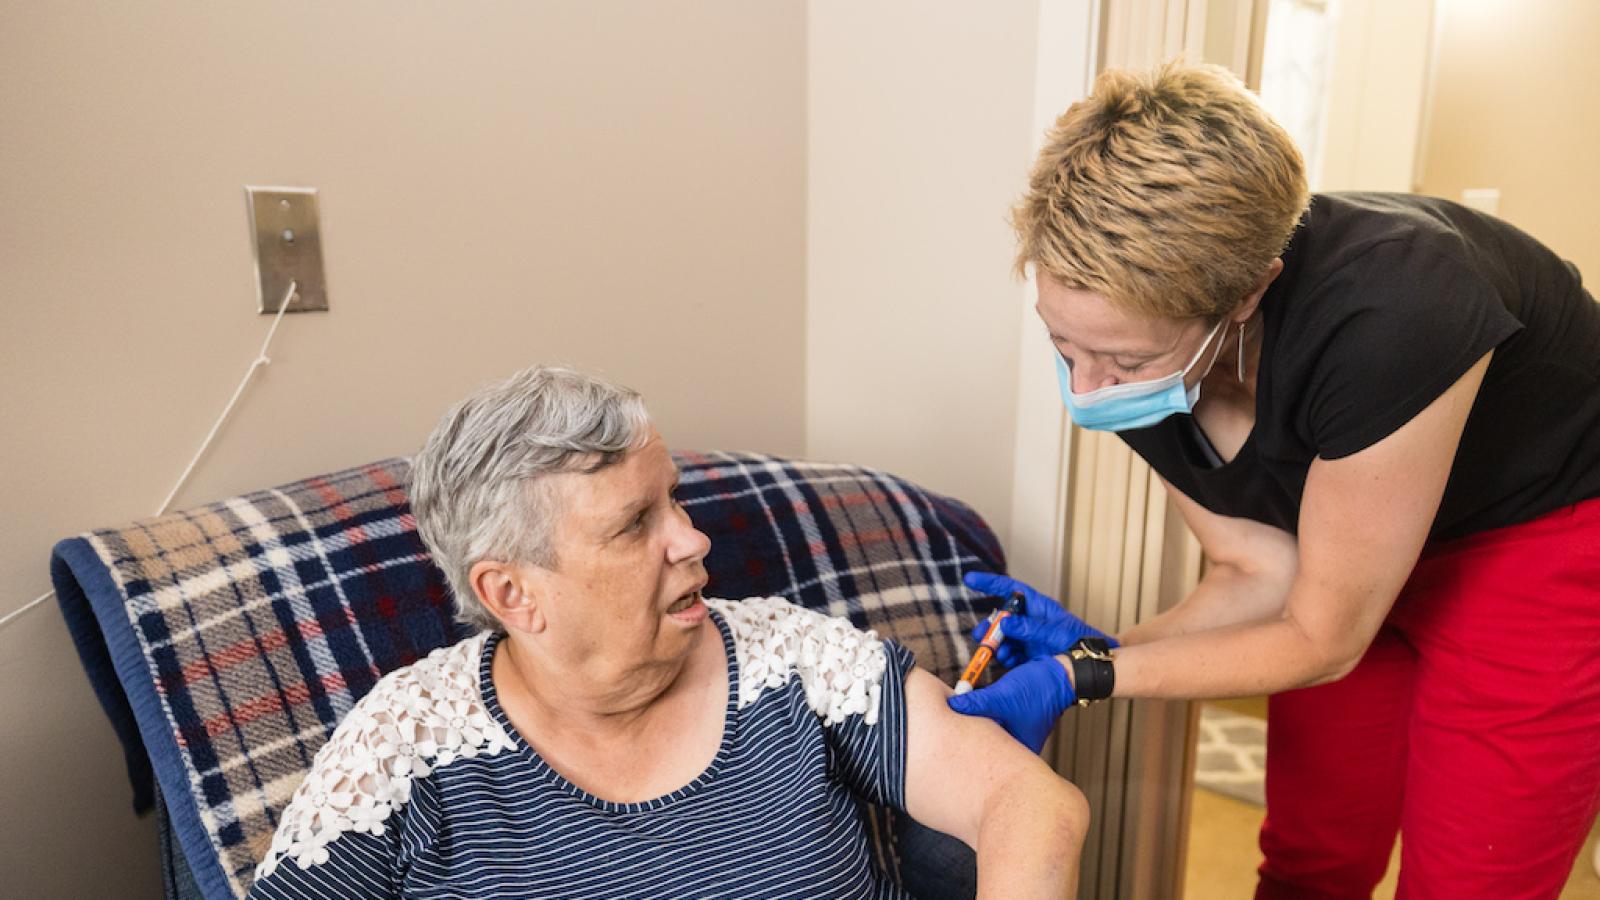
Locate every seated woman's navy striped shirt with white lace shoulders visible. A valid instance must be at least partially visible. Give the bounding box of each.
[250,597,912,900]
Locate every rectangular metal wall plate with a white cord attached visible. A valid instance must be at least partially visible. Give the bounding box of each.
[245,186,328,314]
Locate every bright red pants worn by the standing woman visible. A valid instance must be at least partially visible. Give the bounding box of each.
[1256,500,1600,900]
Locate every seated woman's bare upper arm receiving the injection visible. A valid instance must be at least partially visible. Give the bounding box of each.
[906,669,1075,849]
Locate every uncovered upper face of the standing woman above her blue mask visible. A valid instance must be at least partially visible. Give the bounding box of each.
[1034,272,1214,394]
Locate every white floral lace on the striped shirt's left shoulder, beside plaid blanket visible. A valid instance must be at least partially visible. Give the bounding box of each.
[256,634,514,879]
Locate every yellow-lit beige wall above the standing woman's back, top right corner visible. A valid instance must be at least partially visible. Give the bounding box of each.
[1421,0,1600,277]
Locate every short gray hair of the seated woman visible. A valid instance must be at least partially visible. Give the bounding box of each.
[410,365,650,631]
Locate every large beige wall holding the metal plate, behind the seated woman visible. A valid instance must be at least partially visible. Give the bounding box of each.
[0,0,800,897]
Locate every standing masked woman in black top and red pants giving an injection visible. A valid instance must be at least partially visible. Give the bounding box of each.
[950,64,1600,900]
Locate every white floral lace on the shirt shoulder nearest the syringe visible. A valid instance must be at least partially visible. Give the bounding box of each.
[706,597,888,725]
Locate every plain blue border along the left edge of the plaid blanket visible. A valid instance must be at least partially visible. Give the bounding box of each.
[50,538,235,900]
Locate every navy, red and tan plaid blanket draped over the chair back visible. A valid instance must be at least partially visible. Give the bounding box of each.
[51,453,1005,898]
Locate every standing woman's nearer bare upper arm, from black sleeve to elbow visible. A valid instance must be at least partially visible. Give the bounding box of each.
[1285,352,1493,674]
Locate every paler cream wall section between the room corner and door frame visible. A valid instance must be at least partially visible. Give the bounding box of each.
[806,0,1054,538]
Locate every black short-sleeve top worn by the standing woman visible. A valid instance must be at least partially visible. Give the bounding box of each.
[1122,194,1600,540]
